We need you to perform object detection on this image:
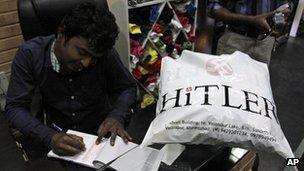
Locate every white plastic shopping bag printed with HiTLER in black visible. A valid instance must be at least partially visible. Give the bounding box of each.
[142,50,293,158]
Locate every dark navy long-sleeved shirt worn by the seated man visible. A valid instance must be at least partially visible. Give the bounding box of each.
[5,36,136,147]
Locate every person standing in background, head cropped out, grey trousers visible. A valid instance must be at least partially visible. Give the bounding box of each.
[208,0,290,65]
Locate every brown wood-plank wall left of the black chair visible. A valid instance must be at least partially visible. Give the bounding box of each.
[0,0,23,75]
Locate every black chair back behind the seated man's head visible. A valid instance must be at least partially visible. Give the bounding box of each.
[18,0,109,40]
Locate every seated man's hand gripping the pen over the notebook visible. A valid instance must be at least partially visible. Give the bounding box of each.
[51,133,85,156]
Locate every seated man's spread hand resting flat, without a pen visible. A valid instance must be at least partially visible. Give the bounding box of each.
[96,118,132,146]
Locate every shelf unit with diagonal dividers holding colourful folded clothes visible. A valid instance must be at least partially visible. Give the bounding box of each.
[128,0,197,107]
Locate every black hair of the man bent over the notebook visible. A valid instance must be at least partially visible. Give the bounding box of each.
[60,2,119,54]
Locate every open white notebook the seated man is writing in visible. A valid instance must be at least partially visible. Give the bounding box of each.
[47,130,138,169]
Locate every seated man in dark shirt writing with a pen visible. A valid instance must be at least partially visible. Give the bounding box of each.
[5,3,136,155]
